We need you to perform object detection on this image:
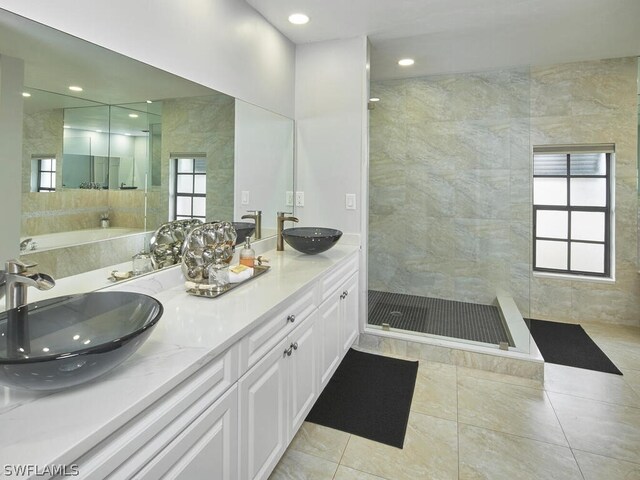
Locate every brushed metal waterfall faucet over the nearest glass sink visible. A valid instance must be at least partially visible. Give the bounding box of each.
[0,260,56,310]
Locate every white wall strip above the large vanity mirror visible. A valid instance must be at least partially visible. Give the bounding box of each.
[0,0,295,117]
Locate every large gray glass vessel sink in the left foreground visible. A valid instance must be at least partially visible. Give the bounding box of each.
[0,292,163,390]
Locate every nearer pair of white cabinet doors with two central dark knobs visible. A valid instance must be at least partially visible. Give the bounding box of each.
[238,312,318,480]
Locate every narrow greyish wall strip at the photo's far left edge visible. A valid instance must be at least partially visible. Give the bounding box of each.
[0,55,24,262]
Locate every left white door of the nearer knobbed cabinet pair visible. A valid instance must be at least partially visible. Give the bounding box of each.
[239,338,289,480]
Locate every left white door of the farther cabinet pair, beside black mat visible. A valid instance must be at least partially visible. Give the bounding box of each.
[316,292,341,392]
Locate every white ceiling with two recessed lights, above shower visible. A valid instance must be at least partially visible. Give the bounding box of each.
[246,0,640,79]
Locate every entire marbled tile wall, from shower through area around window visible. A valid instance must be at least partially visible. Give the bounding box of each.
[369,58,640,325]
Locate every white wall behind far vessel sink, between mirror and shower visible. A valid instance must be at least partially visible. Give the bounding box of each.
[295,37,368,233]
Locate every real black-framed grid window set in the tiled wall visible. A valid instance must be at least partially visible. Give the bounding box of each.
[533,145,613,277]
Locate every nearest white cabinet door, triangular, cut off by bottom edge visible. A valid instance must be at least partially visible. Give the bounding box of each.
[133,386,238,480]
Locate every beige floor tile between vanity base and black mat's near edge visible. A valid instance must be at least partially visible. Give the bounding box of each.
[289,422,350,463]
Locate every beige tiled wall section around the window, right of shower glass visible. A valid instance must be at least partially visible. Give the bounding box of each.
[531,57,640,325]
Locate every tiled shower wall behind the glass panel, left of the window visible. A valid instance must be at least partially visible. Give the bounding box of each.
[369,69,531,312]
